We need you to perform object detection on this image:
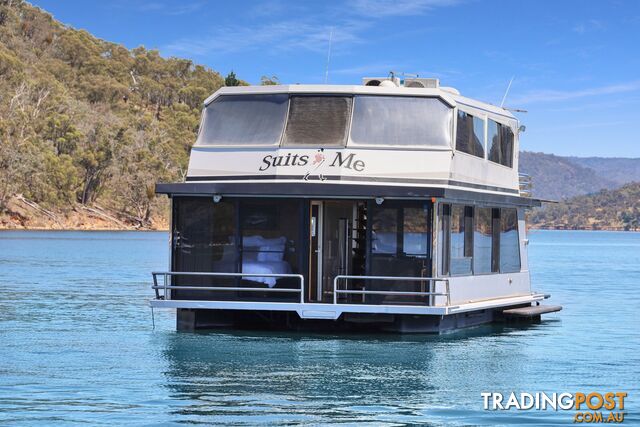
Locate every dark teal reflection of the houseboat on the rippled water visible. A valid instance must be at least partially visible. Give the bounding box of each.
[162,325,538,423]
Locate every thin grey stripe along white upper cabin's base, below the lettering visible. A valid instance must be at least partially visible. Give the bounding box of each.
[187,175,519,195]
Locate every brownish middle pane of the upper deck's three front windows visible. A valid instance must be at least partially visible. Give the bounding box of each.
[283,96,352,146]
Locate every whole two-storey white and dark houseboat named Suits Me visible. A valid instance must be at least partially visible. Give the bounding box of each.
[150,76,560,333]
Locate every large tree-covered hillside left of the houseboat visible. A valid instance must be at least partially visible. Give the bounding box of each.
[0,0,224,227]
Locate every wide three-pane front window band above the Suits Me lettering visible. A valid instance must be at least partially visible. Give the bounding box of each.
[196,94,453,148]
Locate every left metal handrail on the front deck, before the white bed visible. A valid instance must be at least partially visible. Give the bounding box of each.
[151,271,304,303]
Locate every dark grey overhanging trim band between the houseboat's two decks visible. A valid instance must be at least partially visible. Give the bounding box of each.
[156,182,541,207]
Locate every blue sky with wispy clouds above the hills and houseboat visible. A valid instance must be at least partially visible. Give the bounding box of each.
[32,0,640,157]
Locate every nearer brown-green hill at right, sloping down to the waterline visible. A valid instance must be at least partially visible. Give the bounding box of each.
[530,182,640,231]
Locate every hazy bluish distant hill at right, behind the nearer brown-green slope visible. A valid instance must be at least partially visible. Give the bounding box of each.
[520,151,640,200]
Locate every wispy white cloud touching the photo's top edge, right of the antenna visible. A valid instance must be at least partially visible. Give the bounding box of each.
[351,0,461,18]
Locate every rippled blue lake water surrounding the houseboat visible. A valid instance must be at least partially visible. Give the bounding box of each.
[0,231,640,425]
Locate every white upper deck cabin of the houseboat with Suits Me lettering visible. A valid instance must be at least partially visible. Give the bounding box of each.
[158,79,536,204]
